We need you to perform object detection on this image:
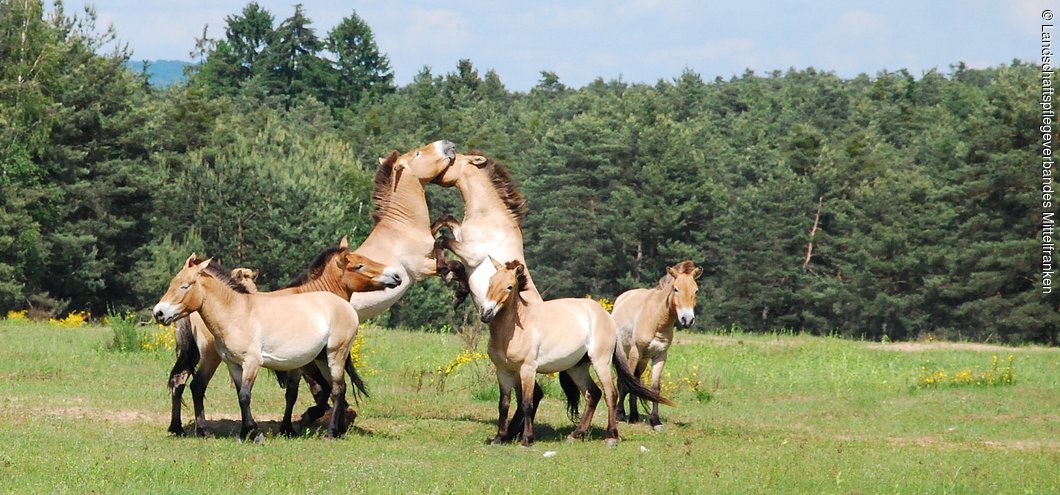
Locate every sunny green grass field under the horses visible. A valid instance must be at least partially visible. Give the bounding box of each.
[0,320,1060,494]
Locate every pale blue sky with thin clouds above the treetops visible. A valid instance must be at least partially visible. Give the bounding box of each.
[65,0,1060,91]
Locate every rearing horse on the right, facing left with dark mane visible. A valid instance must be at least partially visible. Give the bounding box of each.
[430,152,541,308]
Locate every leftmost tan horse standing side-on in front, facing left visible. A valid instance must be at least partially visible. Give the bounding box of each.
[153,253,375,441]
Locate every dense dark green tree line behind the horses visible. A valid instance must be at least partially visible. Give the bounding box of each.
[0,0,1060,342]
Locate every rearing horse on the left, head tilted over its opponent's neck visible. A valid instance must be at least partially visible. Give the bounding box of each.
[350,141,456,319]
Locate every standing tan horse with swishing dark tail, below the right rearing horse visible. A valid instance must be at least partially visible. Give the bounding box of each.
[480,258,672,446]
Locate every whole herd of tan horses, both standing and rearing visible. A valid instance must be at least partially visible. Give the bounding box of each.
[153,141,702,446]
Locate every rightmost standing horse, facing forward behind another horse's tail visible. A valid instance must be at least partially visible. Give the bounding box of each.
[611,261,703,431]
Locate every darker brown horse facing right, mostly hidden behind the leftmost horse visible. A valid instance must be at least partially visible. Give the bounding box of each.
[169,242,401,436]
